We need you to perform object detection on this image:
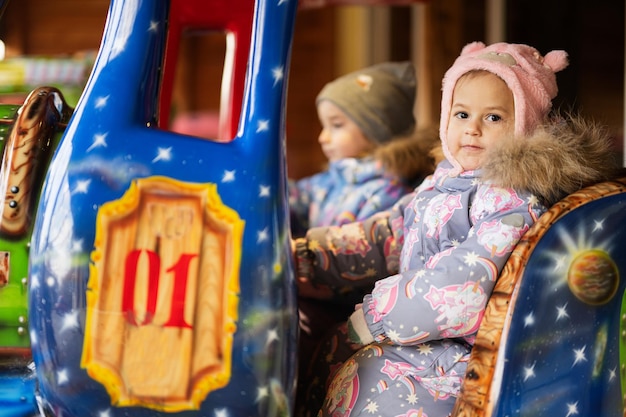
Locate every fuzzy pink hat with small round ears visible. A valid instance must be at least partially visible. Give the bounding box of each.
[439,42,568,175]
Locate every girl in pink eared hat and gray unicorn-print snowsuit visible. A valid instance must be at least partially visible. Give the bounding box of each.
[295,42,617,417]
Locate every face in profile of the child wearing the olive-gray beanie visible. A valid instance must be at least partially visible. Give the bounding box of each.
[317,100,376,162]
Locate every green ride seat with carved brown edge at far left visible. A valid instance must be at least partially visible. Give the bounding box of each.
[0,88,73,358]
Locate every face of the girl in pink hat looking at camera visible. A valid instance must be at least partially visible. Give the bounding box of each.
[448,71,515,171]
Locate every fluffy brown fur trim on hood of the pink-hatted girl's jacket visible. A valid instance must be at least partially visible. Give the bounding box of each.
[482,115,619,207]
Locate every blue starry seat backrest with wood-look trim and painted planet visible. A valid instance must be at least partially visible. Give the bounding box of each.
[452,178,626,417]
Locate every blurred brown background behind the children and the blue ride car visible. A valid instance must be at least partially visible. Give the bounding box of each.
[0,0,626,178]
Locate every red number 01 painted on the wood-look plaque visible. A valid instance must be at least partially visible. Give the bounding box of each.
[122,249,197,328]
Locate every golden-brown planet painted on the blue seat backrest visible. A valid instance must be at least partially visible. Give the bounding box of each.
[567,249,619,305]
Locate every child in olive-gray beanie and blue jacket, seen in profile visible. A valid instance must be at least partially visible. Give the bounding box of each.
[289,62,438,236]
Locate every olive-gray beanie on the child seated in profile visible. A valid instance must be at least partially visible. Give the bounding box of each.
[316,62,417,143]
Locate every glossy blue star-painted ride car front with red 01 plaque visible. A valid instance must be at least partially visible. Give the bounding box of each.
[0,0,297,417]
